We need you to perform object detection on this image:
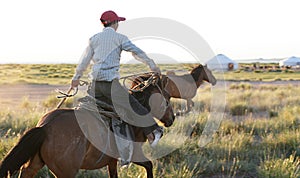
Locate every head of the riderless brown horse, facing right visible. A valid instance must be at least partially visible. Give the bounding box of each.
[191,64,217,86]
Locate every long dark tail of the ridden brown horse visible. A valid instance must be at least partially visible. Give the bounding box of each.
[0,127,46,178]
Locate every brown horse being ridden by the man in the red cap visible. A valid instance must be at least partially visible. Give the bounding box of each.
[0,75,175,178]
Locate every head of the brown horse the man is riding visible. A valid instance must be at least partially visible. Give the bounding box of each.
[130,74,175,127]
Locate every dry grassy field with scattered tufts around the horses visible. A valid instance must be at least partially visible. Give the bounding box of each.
[0,64,300,178]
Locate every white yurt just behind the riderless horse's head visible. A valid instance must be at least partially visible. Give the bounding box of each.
[206,54,239,71]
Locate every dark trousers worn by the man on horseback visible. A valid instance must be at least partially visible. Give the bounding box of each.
[88,80,159,135]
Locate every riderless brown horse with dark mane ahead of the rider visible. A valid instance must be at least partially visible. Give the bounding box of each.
[165,64,217,114]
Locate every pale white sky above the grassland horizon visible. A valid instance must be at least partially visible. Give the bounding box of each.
[0,0,300,63]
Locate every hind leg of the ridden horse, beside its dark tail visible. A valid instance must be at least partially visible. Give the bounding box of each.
[19,154,45,178]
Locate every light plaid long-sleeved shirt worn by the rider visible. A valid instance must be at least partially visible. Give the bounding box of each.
[73,27,156,81]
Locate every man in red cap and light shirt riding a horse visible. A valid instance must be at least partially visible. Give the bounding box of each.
[71,11,163,167]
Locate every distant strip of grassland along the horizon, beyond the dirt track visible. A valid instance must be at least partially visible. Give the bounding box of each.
[0,64,300,84]
